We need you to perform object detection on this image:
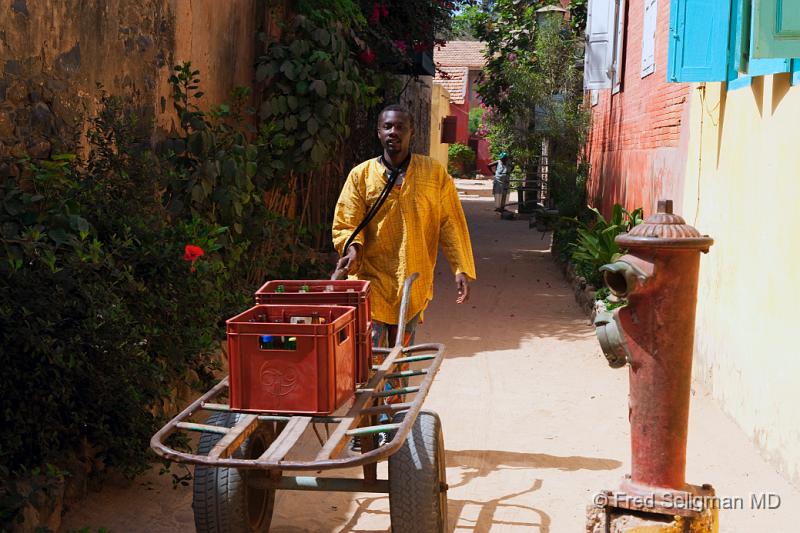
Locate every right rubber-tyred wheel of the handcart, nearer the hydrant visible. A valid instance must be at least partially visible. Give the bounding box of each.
[389,411,447,533]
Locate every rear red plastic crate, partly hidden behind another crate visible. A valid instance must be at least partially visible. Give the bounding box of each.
[256,279,372,383]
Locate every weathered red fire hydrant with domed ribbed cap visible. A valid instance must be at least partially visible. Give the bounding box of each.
[595,200,714,511]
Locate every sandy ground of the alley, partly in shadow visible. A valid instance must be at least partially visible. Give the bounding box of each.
[63,181,800,533]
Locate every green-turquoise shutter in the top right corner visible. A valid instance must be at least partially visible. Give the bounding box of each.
[751,0,800,58]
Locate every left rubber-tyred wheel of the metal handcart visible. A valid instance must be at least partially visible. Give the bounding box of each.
[192,413,282,533]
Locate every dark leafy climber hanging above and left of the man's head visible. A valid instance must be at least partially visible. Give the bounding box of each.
[253,0,466,174]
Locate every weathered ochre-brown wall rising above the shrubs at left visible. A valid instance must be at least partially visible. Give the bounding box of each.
[0,0,268,170]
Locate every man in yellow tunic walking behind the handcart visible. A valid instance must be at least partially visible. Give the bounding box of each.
[333,105,475,346]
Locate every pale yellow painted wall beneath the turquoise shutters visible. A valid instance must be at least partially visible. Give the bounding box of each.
[681,74,800,484]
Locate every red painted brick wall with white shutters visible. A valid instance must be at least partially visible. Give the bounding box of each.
[587,0,690,218]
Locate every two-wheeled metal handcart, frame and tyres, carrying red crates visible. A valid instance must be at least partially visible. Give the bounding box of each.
[150,274,448,533]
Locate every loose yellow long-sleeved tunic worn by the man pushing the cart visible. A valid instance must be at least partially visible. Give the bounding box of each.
[333,154,475,324]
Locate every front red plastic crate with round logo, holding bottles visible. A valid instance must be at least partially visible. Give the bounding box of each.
[227,305,356,414]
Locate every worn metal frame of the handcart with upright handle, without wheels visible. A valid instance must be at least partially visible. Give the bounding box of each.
[150,274,447,493]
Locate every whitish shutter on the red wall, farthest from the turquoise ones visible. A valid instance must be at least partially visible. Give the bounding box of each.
[583,0,616,89]
